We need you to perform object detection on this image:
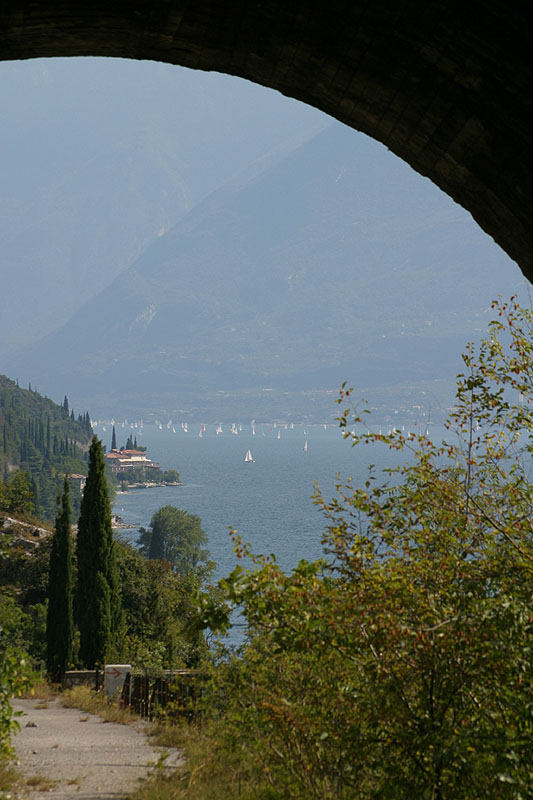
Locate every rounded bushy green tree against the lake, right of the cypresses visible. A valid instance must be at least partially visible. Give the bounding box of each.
[139,506,208,575]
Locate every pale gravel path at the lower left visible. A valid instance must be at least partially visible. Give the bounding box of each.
[13,699,184,800]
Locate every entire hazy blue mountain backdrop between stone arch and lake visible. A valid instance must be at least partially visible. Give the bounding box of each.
[0,59,525,418]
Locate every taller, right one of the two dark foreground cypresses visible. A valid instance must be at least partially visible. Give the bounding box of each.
[75,436,122,669]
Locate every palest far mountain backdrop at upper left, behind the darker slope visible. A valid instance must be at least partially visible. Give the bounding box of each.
[0,58,327,358]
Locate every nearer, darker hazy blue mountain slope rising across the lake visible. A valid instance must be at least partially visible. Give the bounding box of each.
[10,124,522,418]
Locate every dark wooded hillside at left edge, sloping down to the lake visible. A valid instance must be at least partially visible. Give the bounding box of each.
[0,375,92,520]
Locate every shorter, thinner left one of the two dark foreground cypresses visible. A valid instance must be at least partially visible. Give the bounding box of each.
[46,478,74,683]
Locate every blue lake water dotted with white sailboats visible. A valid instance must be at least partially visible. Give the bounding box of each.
[95,423,432,578]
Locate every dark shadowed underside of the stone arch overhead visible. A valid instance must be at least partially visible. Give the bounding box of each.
[0,0,533,280]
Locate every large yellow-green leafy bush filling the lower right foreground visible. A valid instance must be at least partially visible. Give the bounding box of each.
[191,301,533,800]
